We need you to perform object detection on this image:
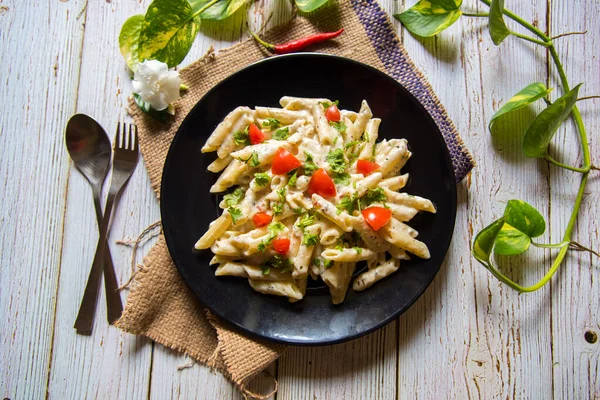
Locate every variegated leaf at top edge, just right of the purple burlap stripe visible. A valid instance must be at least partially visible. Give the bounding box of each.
[394,0,462,37]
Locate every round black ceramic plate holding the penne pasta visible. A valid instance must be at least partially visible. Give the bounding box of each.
[161,53,456,345]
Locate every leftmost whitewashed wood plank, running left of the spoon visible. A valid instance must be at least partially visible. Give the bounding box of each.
[0,0,85,399]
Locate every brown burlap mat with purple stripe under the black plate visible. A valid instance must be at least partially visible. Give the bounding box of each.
[117,0,473,391]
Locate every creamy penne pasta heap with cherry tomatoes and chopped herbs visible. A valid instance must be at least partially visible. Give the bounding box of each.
[195,96,436,304]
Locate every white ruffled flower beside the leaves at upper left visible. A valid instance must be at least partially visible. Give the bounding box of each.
[132,60,181,111]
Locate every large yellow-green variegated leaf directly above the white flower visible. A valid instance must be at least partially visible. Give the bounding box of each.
[139,0,200,67]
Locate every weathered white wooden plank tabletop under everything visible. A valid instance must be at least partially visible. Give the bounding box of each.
[0,0,600,400]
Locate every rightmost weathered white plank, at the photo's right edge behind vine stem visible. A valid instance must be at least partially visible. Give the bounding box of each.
[549,0,600,399]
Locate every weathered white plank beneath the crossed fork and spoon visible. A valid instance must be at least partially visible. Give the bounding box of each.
[48,2,159,398]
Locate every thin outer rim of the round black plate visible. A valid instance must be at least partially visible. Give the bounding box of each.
[159,52,458,347]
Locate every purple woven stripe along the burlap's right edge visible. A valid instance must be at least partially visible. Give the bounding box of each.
[351,0,473,182]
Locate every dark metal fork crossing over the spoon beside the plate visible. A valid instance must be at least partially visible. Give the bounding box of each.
[74,123,139,335]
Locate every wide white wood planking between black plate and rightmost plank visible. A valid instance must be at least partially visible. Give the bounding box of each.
[398,2,551,398]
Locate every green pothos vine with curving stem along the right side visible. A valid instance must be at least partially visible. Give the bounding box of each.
[394,0,600,292]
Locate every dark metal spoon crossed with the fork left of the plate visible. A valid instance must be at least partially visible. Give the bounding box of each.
[65,114,123,335]
